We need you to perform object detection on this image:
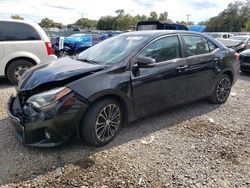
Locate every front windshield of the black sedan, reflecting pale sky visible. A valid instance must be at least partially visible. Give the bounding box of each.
[78,35,148,64]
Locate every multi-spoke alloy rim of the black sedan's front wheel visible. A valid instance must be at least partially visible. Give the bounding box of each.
[95,104,121,142]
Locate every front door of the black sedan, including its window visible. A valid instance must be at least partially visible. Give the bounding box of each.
[132,35,187,116]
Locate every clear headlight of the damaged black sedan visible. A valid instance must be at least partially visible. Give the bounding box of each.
[27,87,71,108]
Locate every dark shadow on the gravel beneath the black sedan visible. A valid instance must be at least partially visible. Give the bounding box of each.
[0,100,220,185]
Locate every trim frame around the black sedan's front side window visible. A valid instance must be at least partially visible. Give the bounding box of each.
[130,33,184,67]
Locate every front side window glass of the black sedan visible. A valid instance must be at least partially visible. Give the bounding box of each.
[139,36,181,63]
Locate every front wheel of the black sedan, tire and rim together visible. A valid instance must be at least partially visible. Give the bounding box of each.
[80,98,123,146]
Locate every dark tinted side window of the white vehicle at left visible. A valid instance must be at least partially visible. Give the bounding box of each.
[0,22,41,41]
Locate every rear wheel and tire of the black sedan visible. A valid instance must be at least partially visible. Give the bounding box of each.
[209,74,232,104]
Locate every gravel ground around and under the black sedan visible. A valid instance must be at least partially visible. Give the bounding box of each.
[0,75,250,188]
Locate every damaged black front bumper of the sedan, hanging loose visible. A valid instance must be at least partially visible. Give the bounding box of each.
[7,94,88,147]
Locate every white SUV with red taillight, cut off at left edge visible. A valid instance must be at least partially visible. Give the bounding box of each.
[0,20,56,84]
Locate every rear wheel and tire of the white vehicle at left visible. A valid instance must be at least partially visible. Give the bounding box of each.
[6,59,33,85]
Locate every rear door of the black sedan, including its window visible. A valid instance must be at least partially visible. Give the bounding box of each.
[182,34,218,101]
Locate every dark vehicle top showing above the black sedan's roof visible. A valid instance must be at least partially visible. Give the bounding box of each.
[136,21,188,31]
